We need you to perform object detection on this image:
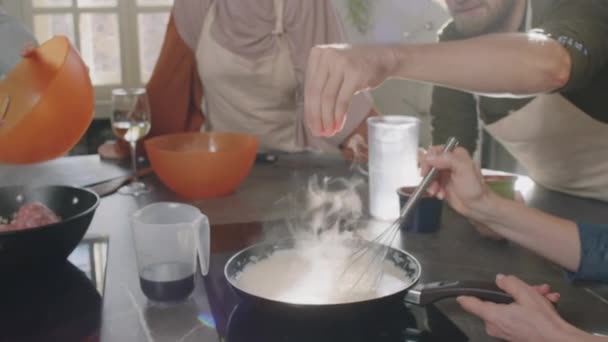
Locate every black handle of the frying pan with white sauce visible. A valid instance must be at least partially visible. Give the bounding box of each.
[405,281,513,305]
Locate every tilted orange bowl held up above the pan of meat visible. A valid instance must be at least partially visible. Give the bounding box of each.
[0,36,95,164]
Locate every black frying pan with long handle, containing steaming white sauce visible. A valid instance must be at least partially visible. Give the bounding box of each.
[224,240,513,317]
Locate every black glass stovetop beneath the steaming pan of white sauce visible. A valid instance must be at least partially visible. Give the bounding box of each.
[203,250,468,342]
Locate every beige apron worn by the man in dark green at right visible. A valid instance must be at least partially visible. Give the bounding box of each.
[485,1,608,201]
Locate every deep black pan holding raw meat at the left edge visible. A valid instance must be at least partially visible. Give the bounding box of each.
[0,186,99,270]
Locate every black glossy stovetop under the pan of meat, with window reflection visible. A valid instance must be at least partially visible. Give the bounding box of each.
[0,237,108,342]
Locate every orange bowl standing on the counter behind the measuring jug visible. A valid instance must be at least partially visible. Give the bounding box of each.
[144,132,258,199]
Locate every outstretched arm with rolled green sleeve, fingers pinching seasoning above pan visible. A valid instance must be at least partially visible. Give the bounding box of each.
[306,1,608,138]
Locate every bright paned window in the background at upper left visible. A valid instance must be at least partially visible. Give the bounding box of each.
[5,0,173,117]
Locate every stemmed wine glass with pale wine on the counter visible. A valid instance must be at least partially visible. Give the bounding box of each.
[112,88,151,196]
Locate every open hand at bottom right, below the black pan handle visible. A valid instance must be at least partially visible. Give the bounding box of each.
[458,275,582,342]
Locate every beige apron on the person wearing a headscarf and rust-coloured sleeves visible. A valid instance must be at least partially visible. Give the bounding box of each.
[196,0,304,152]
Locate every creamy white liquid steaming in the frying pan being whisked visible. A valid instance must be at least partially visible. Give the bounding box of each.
[237,245,412,304]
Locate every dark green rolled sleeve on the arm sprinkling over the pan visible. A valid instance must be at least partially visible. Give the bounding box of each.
[533,0,608,92]
